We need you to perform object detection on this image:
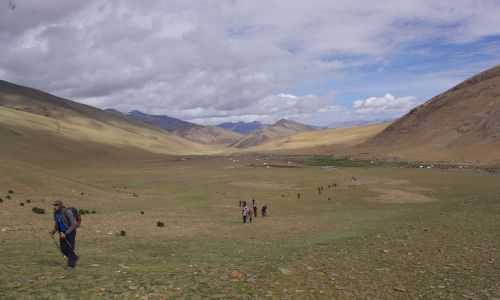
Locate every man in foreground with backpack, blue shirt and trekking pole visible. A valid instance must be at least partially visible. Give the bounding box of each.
[50,200,78,268]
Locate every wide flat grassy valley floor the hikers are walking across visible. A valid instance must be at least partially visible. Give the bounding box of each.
[0,155,500,299]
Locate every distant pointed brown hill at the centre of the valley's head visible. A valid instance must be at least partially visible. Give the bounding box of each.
[231,119,317,148]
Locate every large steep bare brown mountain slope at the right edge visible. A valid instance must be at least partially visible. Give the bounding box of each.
[364,65,500,162]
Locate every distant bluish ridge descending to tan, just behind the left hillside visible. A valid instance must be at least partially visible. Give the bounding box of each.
[126,110,242,145]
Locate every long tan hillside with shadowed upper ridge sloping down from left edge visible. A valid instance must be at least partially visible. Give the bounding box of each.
[0,81,212,161]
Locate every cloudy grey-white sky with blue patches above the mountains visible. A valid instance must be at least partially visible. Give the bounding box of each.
[0,0,500,126]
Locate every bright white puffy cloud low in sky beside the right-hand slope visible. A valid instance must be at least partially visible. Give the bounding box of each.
[353,94,416,116]
